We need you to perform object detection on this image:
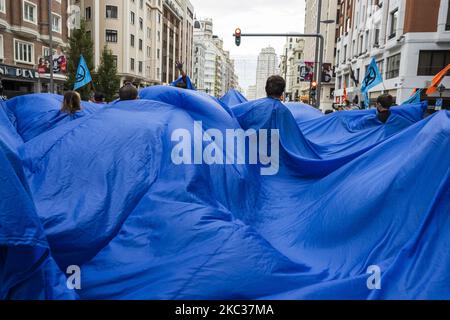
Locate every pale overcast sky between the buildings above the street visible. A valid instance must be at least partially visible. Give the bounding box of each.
[190,0,305,90]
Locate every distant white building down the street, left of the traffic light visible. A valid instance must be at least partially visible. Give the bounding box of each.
[193,19,239,97]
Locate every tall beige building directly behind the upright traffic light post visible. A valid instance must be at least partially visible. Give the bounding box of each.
[302,0,339,111]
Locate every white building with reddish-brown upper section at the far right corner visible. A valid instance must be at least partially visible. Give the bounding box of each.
[336,0,450,105]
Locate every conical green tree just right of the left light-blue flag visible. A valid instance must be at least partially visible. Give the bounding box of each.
[94,46,120,102]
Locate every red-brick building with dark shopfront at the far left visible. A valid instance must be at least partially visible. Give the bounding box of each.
[0,0,70,98]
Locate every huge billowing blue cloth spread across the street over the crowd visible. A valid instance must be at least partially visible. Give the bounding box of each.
[0,86,450,299]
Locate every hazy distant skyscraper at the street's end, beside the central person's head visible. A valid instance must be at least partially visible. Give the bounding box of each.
[256,47,279,99]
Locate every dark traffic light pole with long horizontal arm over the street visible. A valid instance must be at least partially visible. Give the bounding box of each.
[233,33,325,108]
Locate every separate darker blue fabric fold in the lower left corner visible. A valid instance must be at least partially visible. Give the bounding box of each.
[0,141,77,300]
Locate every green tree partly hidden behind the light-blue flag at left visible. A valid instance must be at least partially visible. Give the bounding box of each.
[66,20,94,100]
